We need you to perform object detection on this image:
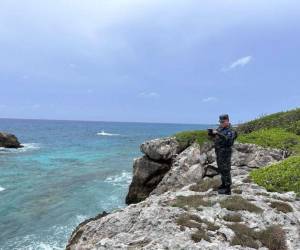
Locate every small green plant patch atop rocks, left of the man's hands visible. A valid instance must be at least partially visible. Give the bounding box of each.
[174,130,210,148]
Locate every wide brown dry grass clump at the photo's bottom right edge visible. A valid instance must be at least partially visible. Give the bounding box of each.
[228,223,287,250]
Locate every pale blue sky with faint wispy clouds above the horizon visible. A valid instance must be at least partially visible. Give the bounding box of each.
[0,0,300,123]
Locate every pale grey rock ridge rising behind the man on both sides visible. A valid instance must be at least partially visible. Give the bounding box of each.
[150,143,285,194]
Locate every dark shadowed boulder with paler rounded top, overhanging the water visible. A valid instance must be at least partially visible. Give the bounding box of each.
[125,137,188,204]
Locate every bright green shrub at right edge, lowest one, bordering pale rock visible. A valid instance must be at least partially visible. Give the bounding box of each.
[250,156,300,197]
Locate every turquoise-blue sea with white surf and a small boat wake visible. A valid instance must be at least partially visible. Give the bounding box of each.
[0,119,209,250]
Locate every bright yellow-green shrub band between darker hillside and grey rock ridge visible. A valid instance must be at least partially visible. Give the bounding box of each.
[238,128,300,153]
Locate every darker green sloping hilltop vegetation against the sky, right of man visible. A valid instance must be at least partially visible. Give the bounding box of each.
[237,108,300,133]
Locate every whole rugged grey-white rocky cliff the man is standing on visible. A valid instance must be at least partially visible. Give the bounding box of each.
[67,138,300,250]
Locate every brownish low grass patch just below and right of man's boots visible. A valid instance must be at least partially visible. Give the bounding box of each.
[220,195,263,213]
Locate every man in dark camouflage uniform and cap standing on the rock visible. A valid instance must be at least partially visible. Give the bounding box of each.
[209,114,237,195]
